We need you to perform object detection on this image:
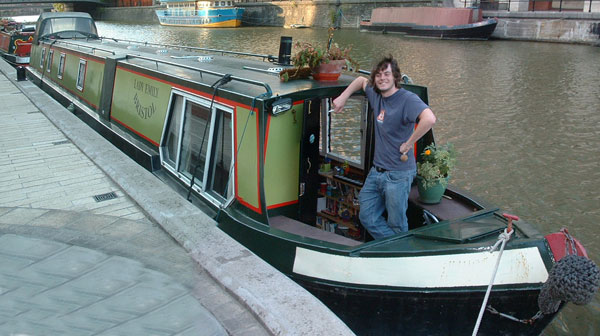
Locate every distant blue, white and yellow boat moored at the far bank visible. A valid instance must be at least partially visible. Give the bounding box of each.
[156,0,244,28]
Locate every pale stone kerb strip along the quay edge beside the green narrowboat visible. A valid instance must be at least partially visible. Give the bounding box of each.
[0,61,353,335]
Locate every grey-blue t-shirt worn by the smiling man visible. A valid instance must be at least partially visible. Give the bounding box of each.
[365,85,429,170]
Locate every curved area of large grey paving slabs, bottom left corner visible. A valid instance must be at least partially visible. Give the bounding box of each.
[0,234,227,335]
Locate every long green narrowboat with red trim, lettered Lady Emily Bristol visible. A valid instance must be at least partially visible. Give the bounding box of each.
[28,13,597,335]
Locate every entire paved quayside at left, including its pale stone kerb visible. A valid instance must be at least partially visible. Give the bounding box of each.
[0,60,352,335]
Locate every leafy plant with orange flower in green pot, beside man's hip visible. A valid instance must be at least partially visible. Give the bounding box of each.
[417,144,456,204]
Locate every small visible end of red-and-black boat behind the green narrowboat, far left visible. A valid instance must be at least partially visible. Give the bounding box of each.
[0,22,34,66]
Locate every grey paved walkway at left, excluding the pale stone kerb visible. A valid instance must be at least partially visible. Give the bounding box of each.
[0,64,268,335]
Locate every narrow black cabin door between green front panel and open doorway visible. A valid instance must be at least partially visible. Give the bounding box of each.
[298,99,321,225]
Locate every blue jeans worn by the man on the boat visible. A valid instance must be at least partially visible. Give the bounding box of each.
[358,168,416,239]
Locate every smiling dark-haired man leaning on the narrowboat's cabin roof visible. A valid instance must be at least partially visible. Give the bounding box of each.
[333,56,436,239]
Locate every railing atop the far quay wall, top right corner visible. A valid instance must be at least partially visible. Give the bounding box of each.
[474,0,600,13]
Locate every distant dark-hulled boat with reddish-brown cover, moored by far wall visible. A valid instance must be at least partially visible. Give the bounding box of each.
[360,7,498,40]
